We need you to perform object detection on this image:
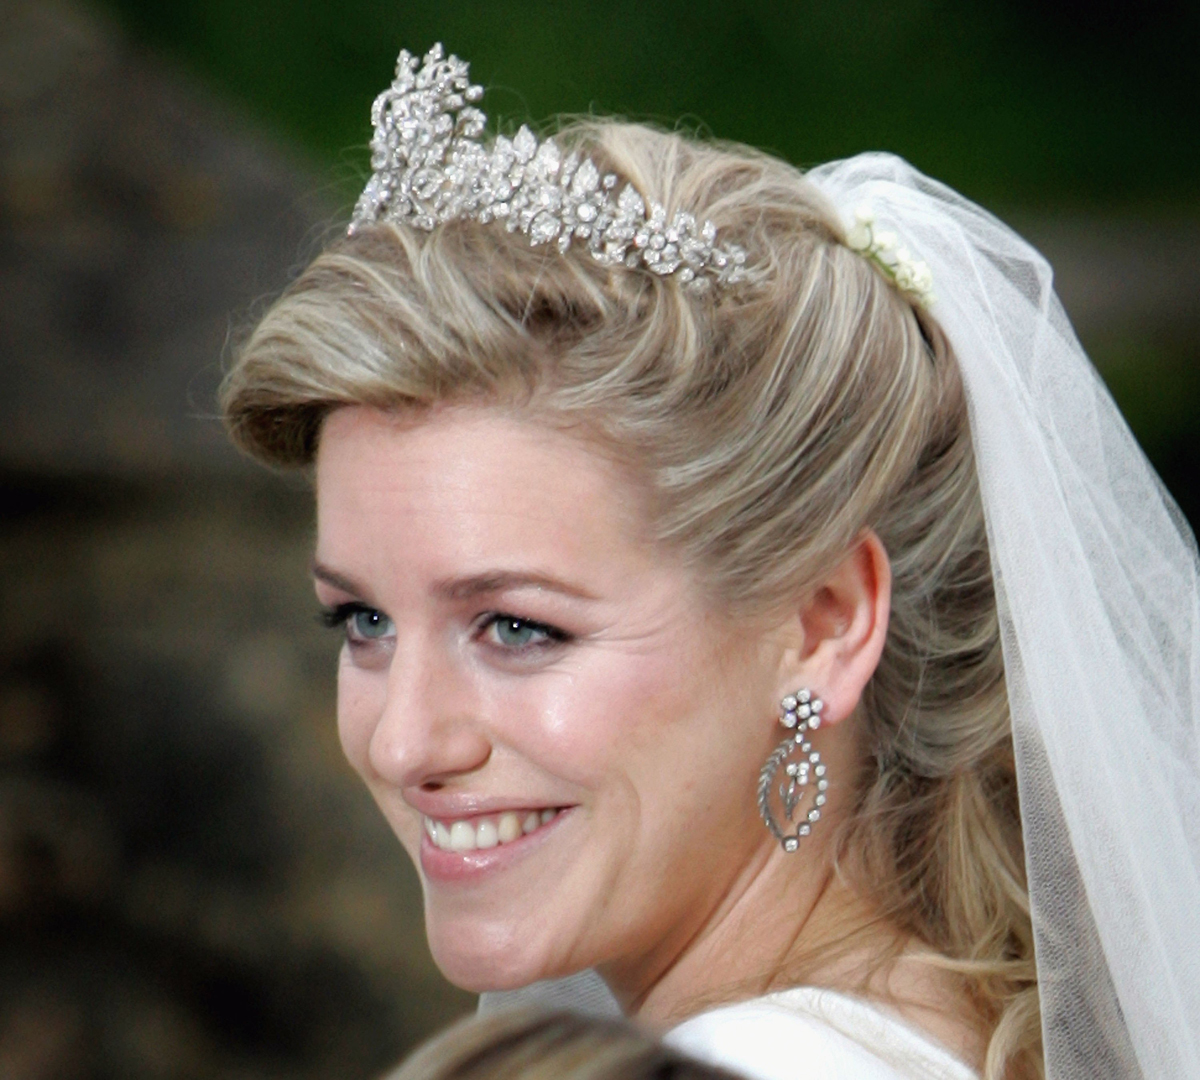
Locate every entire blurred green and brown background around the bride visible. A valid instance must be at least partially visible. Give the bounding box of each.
[0,0,1200,1080]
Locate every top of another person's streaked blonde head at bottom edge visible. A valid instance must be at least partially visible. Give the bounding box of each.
[388,1010,734,1080]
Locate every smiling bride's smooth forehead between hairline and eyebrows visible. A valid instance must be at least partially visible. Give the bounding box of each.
[317,406,650,585]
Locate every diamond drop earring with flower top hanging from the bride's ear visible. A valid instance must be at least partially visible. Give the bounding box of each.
[758,690,829,853]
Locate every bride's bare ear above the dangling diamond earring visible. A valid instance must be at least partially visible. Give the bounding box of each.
[781,530,892,724]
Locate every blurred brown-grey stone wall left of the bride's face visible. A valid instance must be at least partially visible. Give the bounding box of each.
[0,0,473,1080]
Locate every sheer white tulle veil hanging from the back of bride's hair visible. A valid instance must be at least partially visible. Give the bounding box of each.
[484,154,1200,1080]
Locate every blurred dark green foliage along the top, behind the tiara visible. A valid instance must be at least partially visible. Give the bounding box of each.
[87,0,1200,210]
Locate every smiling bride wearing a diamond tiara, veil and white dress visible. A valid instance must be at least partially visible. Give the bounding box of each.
[224,50,1200,1080]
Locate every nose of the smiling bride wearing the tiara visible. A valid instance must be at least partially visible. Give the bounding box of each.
[367,641,492,788]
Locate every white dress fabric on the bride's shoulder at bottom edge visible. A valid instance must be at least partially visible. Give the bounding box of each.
[665,986,978,1080]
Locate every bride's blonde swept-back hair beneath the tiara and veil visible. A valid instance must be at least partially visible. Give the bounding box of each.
[223,121,1043,1080]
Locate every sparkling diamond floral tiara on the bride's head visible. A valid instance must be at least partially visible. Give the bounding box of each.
[349,44,748,290]
